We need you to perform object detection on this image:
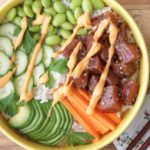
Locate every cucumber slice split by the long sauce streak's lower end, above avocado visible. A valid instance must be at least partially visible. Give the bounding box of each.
[14,73,33,96]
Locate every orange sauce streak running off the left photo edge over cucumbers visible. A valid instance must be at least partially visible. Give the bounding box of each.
[0,68,16,88]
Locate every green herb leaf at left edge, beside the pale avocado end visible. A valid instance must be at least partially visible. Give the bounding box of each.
[0,93,18,117]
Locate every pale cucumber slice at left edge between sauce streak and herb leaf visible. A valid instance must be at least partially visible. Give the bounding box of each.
[0,81,15,99]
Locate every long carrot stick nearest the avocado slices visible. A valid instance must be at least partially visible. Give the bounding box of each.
[61,99,100,142]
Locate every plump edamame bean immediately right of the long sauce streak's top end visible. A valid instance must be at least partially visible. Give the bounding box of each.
[52,14,66,27]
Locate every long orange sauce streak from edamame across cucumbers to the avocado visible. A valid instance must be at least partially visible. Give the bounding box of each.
[20,17,51,102]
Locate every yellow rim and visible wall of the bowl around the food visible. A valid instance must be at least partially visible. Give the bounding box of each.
[0,0,149,150]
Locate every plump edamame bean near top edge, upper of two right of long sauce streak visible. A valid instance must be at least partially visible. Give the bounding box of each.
[54,1,66,13]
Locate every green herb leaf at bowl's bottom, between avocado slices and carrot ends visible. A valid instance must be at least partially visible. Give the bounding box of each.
[66,131,94,146]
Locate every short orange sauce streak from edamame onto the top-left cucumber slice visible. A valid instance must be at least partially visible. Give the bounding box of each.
[14,17,28,50]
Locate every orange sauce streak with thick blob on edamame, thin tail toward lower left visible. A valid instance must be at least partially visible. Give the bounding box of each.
[54,12,91,57]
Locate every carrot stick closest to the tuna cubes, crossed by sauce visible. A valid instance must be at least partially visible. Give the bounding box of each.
[76,89,121,125]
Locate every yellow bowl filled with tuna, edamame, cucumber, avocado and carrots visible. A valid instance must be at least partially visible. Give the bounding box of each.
[0,0,149,150]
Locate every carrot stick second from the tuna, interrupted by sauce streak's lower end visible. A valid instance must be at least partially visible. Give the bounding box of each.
[71,88,116,131]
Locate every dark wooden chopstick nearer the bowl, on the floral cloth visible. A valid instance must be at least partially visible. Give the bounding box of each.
[127,121,150,150]
